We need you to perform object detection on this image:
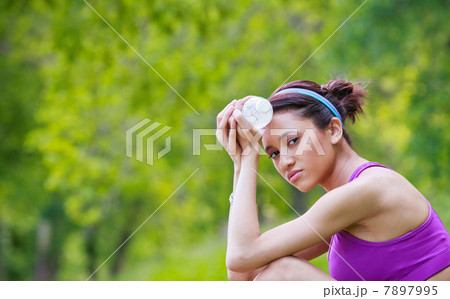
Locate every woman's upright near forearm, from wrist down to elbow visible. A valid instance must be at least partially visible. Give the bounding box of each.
[227,155,261,259]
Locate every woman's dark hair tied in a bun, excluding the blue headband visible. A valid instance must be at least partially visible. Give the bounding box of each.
[269,79,367,146]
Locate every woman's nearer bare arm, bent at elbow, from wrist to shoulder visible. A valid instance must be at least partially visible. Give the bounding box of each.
[227,170,380,272]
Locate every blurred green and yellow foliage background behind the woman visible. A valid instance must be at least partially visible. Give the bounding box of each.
[0,0,450,280]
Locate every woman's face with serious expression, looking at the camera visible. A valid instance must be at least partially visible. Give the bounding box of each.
[262,112,335,192]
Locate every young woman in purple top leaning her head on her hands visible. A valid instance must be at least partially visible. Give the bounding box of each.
[217,80,450,280]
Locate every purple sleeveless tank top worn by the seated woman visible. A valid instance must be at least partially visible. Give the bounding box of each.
[328,162,450,281]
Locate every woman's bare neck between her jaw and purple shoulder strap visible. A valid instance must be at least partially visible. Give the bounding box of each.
[319,142,368,192]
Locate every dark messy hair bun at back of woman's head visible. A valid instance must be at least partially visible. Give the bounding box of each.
[324,79,367,123]
